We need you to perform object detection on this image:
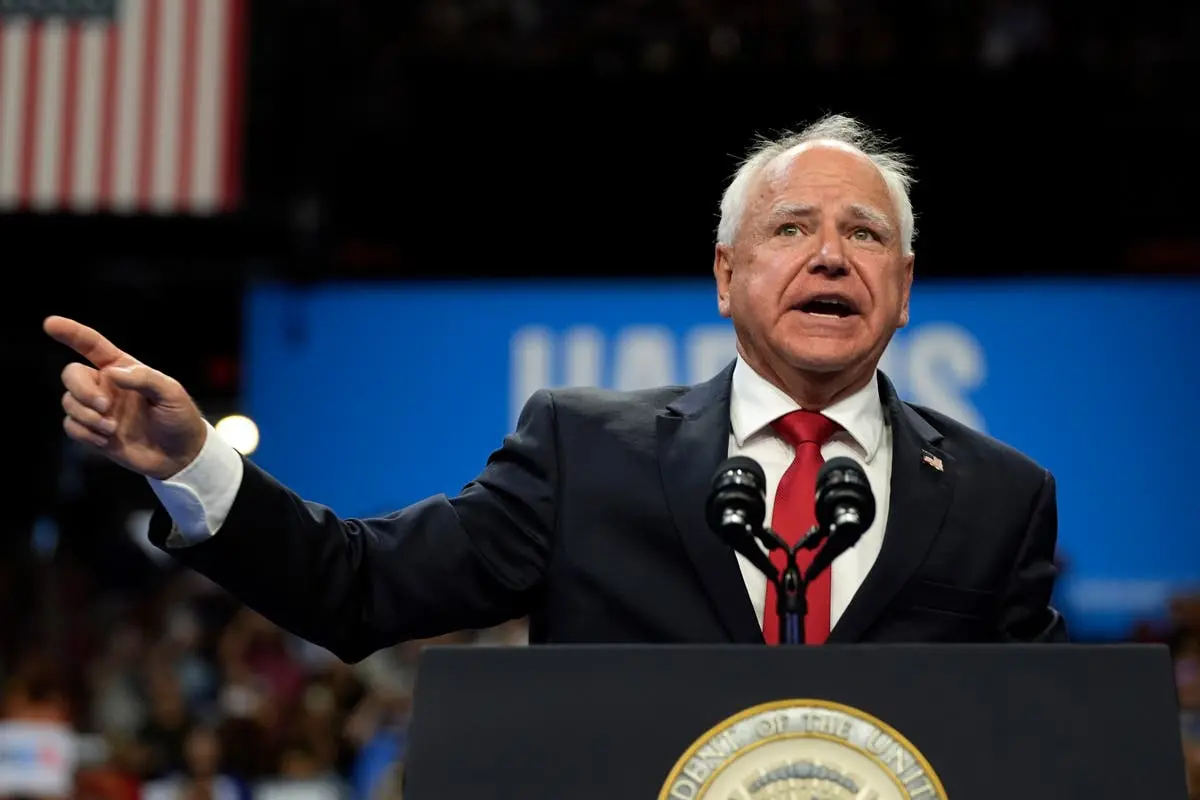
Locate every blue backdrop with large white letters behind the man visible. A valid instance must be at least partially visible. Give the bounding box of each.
[245,281,1200,634]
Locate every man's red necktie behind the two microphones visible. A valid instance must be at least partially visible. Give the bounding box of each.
[762,411,839,644]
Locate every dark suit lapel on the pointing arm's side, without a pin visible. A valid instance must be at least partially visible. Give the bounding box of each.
[658,365,763,643]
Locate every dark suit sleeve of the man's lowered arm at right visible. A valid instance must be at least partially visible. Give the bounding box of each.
[1001,471,1067,642]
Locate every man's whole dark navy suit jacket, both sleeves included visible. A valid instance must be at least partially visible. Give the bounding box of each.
[151,365,1066,662]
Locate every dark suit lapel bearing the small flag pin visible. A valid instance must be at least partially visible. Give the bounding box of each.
[829,373,954,642]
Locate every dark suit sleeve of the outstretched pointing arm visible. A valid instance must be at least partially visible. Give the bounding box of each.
[150,391,559,662]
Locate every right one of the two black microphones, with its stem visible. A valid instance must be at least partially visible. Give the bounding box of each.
[804,456,875,581]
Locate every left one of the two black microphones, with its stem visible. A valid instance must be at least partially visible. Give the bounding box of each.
[704,456,779,576]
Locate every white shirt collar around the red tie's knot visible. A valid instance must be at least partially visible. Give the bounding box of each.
[730,355,884,463]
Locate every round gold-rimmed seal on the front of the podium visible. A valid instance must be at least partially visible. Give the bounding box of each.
[659,699,947,800]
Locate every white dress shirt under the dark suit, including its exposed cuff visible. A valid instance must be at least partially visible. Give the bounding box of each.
[150,357,892,626]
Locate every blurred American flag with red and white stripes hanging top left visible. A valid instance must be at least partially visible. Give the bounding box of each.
[0,0,247,215]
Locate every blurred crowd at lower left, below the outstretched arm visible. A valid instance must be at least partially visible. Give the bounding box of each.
[0,561,528,800]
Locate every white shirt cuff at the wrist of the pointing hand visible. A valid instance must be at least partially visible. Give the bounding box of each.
[146,422,245,547]
